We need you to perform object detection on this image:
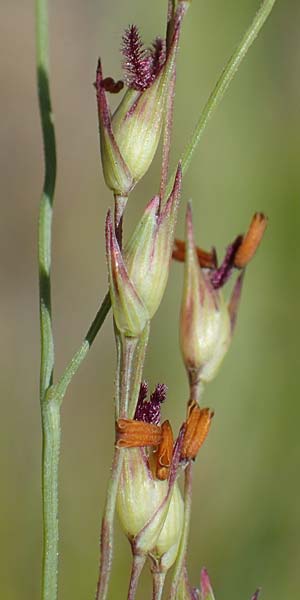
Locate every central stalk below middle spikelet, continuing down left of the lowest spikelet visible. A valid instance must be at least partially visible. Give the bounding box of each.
[96,332,148,600]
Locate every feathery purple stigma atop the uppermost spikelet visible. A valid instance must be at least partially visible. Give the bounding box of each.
[121,25,165,92]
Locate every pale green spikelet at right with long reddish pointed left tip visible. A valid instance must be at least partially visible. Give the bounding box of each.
[180,205,231,382]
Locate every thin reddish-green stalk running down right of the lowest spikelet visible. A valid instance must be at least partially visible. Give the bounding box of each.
[169,462,193,600]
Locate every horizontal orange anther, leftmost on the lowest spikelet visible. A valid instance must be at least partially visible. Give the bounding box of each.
[116,419,162,448]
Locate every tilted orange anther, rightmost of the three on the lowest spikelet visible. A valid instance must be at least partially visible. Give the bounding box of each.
[181,403,214,460]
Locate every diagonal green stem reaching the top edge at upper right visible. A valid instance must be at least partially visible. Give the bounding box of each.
[165,0,276,197]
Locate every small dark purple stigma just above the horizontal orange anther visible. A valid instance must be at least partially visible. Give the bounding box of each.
[134,381,167,425]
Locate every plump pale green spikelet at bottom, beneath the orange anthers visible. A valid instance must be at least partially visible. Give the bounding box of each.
[117,448,183,570]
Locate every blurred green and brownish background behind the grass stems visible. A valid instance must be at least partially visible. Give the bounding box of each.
[0,0,300,600]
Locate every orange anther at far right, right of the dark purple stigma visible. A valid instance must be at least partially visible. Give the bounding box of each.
[234,213,268,269]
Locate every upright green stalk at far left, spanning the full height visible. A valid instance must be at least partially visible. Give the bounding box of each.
[35,0,60,600]
